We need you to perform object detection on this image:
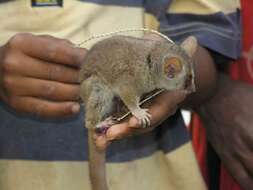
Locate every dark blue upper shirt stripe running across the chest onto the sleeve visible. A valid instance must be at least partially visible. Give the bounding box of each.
[81,0,241,59]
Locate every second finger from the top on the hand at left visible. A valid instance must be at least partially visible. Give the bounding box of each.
[6,54,79,83]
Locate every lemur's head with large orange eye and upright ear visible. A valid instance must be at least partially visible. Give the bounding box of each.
[150,36,198,92]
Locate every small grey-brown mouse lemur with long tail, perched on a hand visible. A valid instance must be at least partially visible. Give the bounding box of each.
[80,36,197,190]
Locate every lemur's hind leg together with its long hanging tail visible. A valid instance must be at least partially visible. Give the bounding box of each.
[81,77,113,190]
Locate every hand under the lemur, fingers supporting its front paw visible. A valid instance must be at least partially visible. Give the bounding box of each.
[94,90,187,149]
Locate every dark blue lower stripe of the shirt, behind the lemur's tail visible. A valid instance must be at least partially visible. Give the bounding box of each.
[0,100,189,162]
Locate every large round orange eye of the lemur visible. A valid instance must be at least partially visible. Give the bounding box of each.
[163,57,182,78]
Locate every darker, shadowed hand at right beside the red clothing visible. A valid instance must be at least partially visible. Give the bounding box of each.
[197,76,253,190]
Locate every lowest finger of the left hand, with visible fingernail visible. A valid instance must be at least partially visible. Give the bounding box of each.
[9,97,80,118]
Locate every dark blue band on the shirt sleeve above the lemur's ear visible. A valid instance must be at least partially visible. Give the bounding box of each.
[160,10,241,58]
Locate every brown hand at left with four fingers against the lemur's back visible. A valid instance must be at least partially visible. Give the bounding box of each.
[0,33,86,118]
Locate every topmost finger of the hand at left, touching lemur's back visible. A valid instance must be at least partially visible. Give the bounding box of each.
[9,33,86,67]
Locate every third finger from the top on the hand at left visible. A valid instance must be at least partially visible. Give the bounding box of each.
[7,76,80,101]
